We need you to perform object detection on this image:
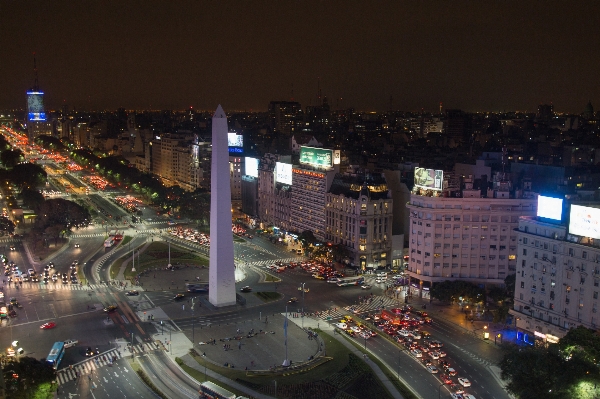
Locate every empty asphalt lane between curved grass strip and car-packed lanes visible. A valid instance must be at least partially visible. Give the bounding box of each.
[353,337,447,398]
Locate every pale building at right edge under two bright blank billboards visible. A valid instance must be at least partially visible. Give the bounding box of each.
[510,204,600,343]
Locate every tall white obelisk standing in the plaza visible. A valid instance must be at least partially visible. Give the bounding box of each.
[208,105,235,307]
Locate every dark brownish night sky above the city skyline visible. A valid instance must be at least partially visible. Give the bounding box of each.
[0,0,600,113]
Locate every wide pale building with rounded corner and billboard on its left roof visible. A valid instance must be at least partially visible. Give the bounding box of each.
[406,168,537,294]
